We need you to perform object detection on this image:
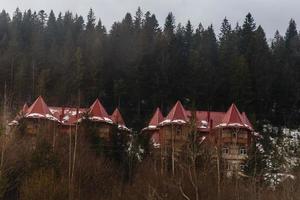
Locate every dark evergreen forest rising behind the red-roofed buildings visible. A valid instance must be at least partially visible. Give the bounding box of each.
[0,8,300,131]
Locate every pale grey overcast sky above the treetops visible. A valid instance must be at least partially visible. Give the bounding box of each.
[0,0,300,38]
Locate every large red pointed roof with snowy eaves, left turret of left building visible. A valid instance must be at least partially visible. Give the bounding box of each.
[25,96,58,121]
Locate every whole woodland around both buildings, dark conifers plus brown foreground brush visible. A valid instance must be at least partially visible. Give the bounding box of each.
[0,8,300,200]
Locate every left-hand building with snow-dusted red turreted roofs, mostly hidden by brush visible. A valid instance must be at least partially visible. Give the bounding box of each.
[9,96,130,140]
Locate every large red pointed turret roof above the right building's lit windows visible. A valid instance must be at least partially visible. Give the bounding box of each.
[221,104,244,127]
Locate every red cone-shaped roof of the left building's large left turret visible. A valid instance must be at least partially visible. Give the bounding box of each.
[26,96,52,117]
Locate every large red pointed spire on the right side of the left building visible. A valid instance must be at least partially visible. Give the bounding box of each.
[89,99,112,123]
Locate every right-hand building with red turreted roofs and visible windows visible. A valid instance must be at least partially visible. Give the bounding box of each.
[142,101,257,175]
